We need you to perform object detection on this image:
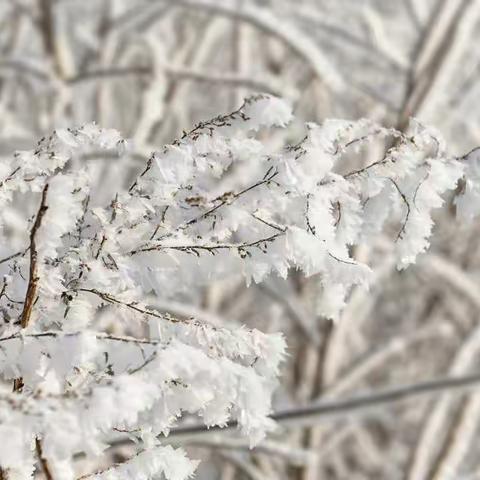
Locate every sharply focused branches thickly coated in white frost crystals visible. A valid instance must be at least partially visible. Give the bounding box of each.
[0,95,479,480]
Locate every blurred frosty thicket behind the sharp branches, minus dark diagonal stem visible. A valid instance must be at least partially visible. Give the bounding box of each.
[0,0,480,480]
